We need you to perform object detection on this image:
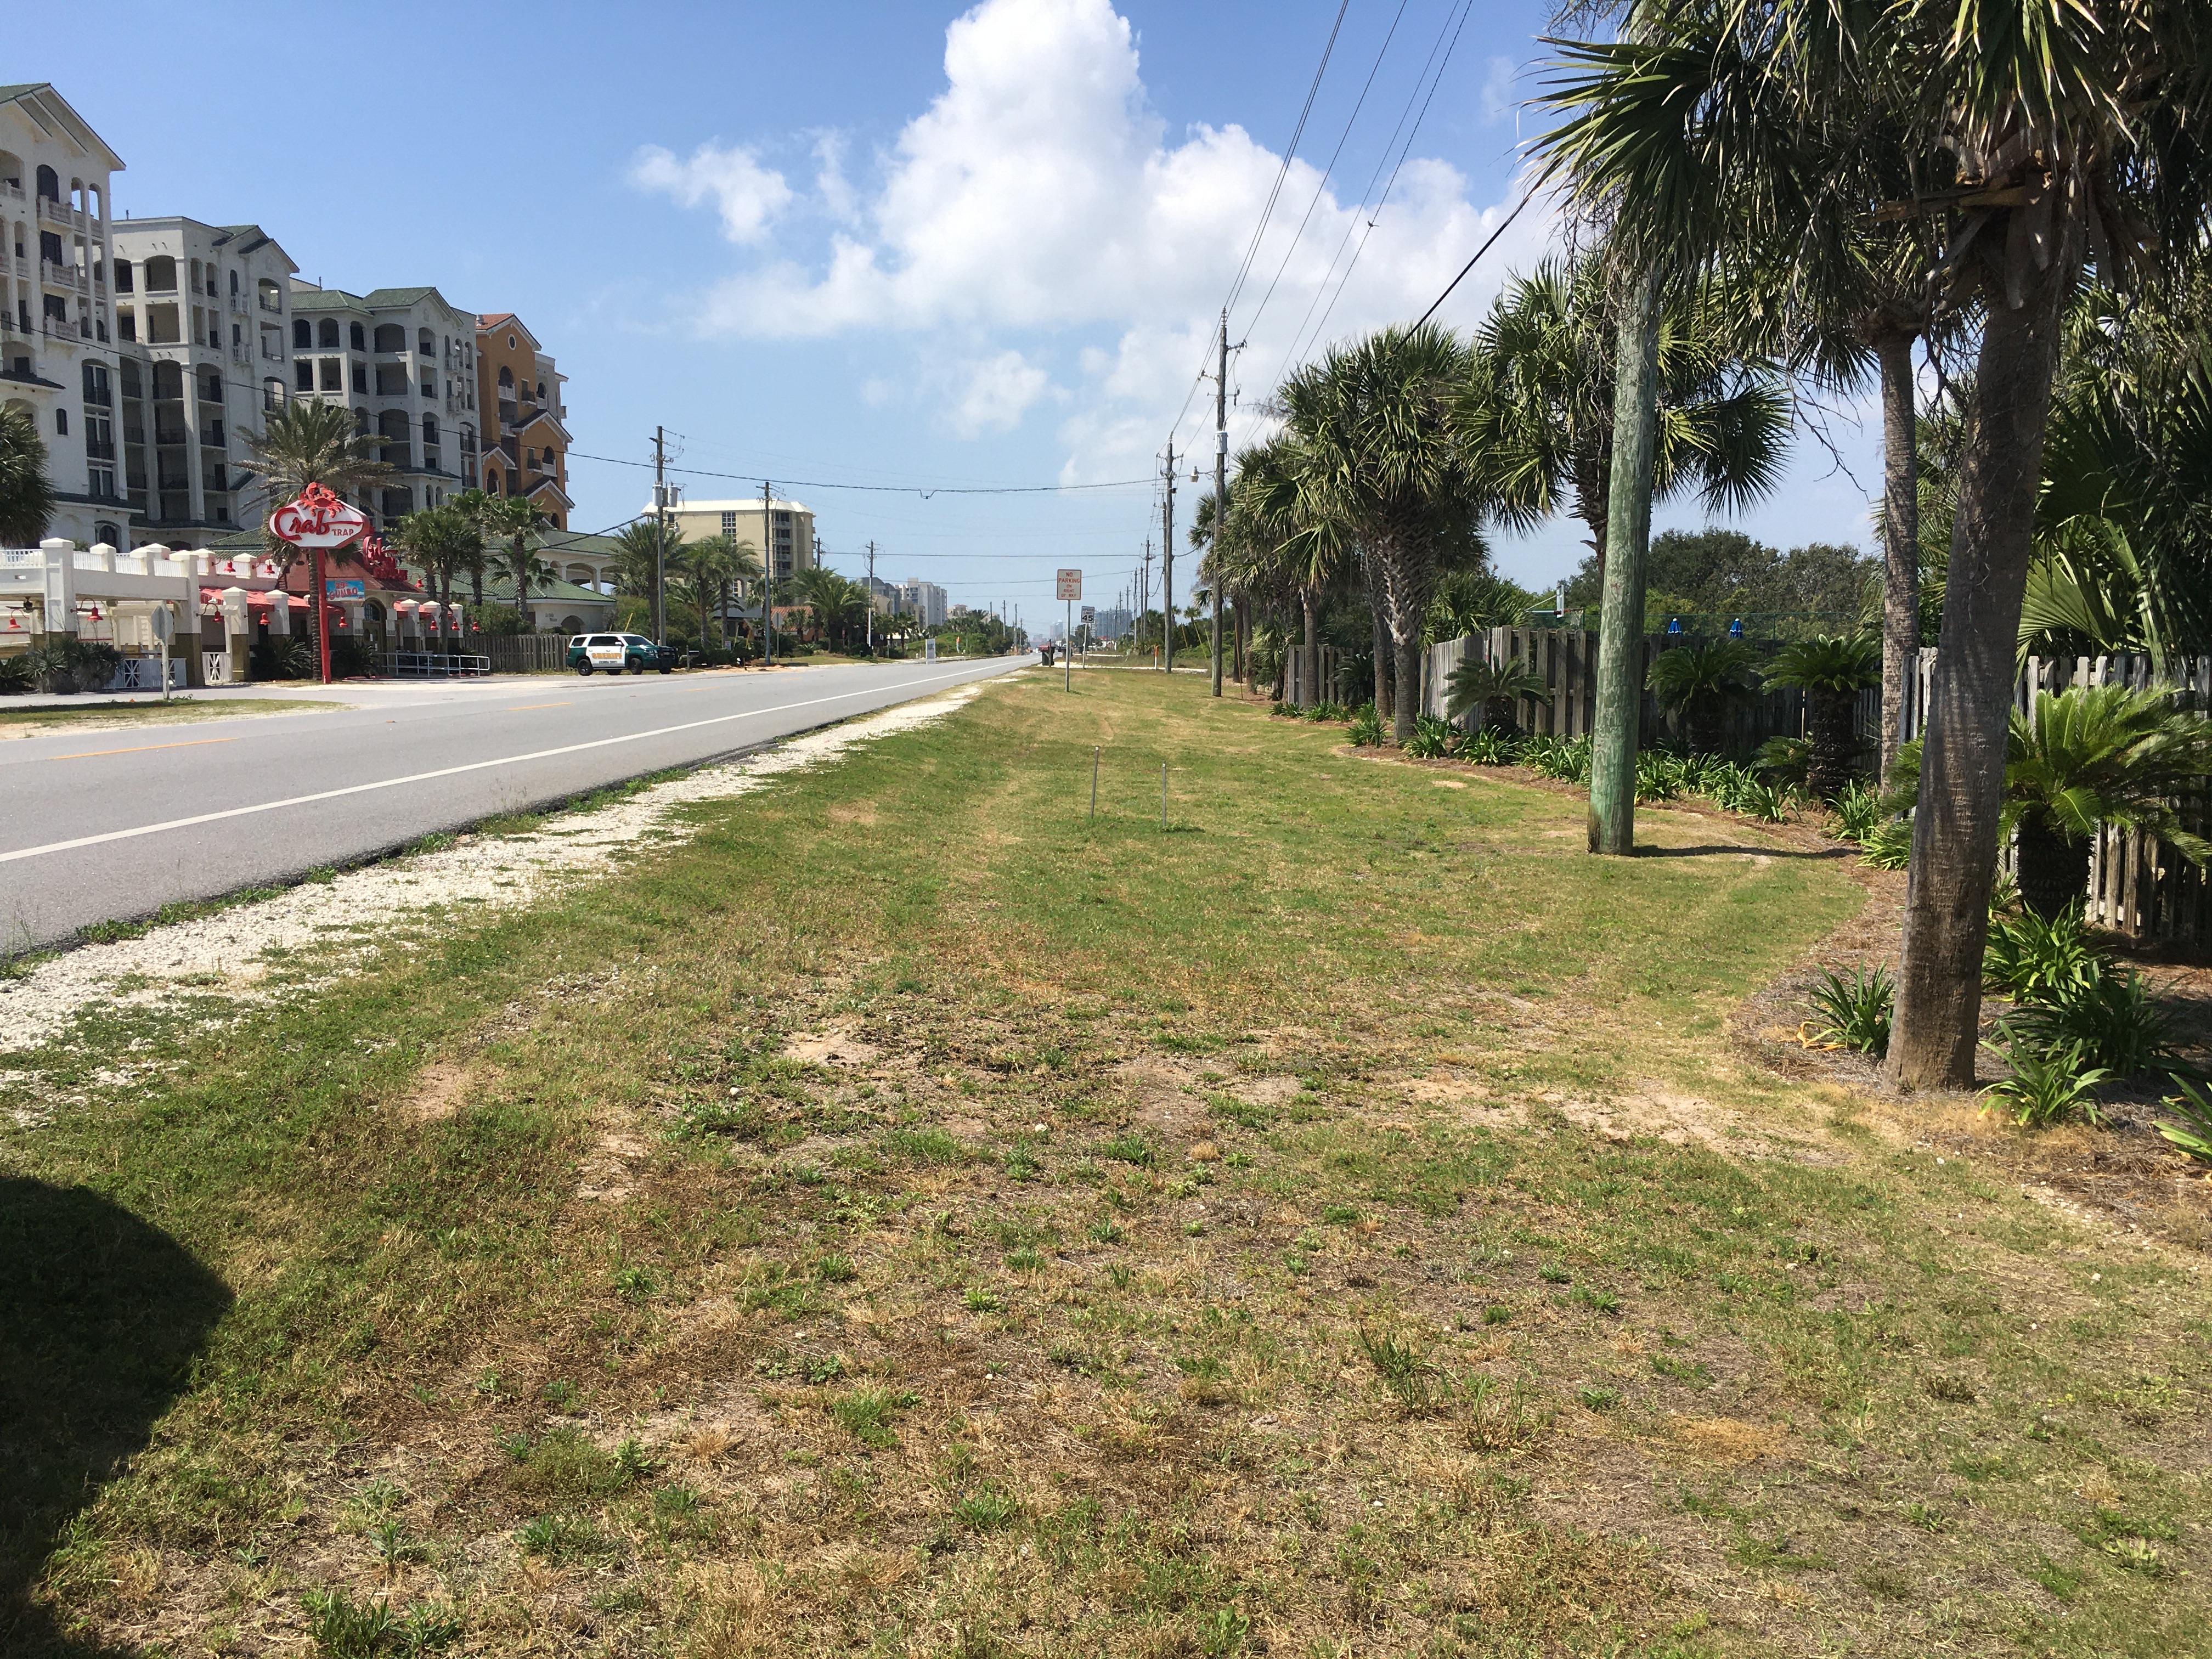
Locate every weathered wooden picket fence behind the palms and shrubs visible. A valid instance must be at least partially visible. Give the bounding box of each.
[1420,628,2212,951]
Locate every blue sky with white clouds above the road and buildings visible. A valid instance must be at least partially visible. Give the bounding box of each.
[74,0,1878,619]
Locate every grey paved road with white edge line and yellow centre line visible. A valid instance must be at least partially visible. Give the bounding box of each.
[0,657,1017,953]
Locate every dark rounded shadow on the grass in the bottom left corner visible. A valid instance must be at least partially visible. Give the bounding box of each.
[0,1177,230,1659]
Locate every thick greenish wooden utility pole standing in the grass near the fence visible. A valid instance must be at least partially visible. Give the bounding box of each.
[1590,270,1659,856]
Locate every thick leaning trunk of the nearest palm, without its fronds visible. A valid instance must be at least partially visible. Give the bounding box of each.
[1889,256,2081,1088]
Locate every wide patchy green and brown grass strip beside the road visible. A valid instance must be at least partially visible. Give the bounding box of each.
[0,673,2212,1657]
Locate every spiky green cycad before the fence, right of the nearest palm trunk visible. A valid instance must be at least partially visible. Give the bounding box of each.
[2004,686,2212,918]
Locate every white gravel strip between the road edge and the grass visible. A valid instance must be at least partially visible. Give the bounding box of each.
[0,681,989,1057]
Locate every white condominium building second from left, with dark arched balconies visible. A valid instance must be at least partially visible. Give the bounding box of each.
[111,217,298,533]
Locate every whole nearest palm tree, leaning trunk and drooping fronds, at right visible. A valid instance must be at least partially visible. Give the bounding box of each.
[1550,0,2212,1088]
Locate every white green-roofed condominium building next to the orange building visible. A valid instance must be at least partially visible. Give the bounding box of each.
[292,276,480,529]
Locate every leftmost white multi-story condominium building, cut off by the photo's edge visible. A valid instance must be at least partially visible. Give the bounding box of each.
[0,82,131,549]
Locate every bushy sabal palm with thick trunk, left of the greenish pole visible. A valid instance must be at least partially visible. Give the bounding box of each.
[1278,325,1502,743]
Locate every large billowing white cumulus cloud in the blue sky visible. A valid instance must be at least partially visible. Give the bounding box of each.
[628,0,1550,462]
